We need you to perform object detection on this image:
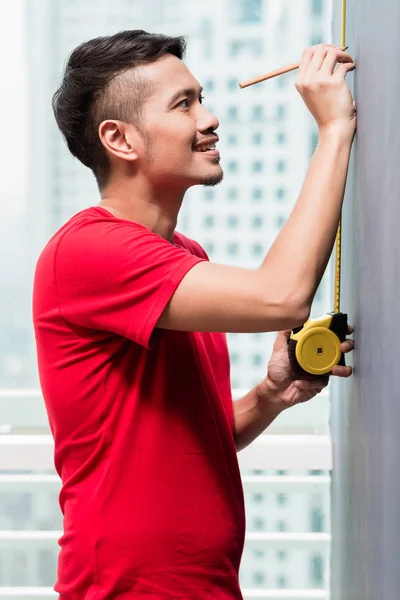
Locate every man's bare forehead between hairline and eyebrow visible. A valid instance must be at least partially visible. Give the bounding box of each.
[138,54,200,102]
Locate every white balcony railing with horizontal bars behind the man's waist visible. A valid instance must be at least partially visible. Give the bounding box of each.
[0,390,332,600]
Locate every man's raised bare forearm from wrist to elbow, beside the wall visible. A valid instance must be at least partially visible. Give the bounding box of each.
[260,130,351,307]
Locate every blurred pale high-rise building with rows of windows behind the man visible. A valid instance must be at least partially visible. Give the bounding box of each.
[0,0,332,588]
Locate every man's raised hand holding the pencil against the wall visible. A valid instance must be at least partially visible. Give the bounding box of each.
[295,44,356,138]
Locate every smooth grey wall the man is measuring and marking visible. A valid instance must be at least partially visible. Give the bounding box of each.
[331,0,400,600]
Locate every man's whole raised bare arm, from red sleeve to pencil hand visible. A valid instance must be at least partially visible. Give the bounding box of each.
[157,45,356,333]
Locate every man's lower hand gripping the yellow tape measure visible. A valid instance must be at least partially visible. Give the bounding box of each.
[257,326,354,410]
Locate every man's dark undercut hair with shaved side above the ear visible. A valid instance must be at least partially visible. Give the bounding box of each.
[52,29,186,190]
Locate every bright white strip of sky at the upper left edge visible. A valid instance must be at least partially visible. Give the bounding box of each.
[0,0,29,213]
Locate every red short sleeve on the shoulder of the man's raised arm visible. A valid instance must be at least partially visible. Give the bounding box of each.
[54,219,205,348]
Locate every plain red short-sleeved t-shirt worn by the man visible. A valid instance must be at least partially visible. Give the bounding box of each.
[33,207,245,600]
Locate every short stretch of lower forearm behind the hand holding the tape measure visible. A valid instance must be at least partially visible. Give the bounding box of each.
[233,386,283,452]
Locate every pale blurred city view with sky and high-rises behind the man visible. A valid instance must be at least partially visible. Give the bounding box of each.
[0,0,337,598]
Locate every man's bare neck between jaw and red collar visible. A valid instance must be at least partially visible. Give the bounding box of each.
[99,175,185,243]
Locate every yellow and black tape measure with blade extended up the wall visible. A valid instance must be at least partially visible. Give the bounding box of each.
[288,0,348,379]
